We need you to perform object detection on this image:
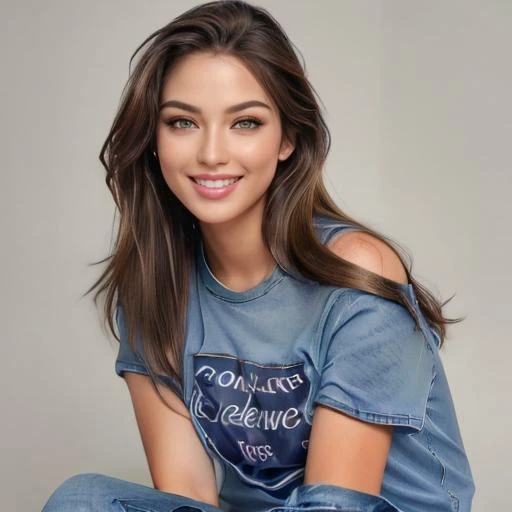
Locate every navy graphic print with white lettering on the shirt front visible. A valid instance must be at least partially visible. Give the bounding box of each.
[190,353,311,491]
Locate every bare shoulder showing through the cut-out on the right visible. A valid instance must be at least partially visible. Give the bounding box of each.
[327,231,408,284]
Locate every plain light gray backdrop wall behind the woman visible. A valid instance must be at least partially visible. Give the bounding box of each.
[0,0,512,511]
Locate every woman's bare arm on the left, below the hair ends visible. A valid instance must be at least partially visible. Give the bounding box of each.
[124,372,219,507]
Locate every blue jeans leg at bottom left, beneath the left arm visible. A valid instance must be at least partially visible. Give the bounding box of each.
[42,473,226,512]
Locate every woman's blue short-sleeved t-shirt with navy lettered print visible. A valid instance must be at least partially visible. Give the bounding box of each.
[115,215,474,512]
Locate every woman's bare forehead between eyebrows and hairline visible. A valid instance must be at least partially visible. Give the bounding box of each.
[162,52,275,110]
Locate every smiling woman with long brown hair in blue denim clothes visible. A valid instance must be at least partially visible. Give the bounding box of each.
[44,1,474,512]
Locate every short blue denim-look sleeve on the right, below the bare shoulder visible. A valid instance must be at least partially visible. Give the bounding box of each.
[314,289,435,431]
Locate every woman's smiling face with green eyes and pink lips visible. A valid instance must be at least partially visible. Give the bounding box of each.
[156,53,293,228]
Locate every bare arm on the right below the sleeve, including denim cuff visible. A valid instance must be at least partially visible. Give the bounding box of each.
[285,404,397,512]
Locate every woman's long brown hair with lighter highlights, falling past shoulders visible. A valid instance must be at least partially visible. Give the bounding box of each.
[86,0,460,408]
